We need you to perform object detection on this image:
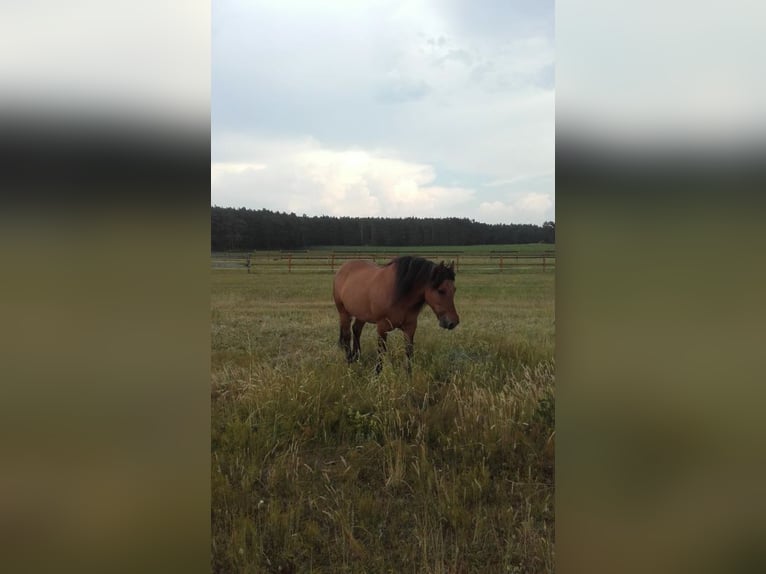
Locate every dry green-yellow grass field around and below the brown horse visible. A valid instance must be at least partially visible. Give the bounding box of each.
[211,258,554,573]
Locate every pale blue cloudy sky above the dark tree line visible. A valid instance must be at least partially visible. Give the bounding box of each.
[211,0,555,225]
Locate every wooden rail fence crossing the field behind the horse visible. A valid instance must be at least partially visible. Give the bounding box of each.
[212,250,556,273]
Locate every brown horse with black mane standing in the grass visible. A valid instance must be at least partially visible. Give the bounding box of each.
[332,256,460,373]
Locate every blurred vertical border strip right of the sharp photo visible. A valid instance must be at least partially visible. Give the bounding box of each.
[556,2,766,573]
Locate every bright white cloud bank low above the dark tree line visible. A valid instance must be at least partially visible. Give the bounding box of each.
[211,140,475,217]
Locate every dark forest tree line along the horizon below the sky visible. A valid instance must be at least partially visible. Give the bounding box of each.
[210,206,556,251]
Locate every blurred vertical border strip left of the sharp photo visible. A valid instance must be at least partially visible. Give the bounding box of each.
[0,1,210,572]
